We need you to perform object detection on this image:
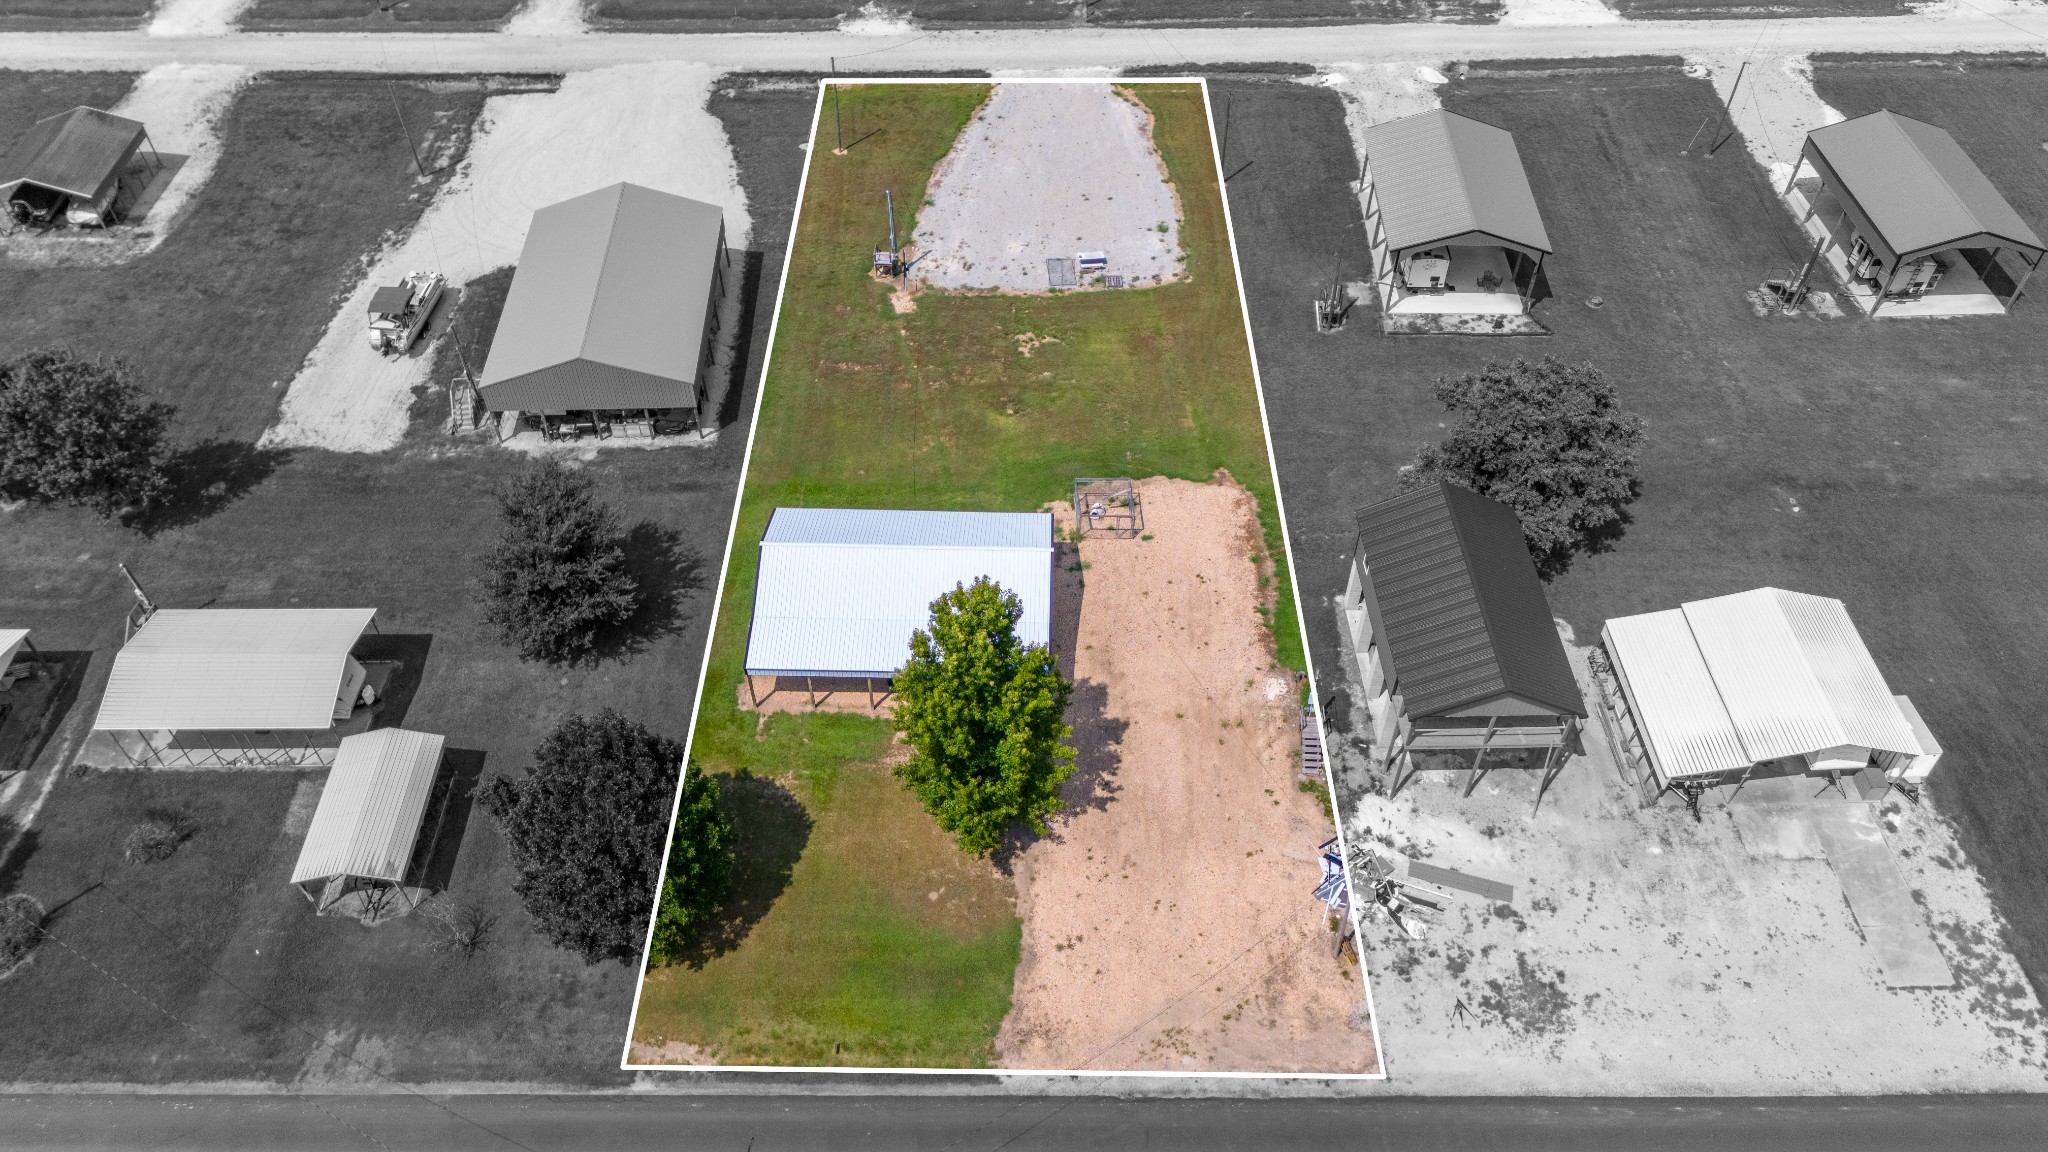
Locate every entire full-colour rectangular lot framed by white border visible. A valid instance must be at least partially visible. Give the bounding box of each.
[610,82,1378,1076]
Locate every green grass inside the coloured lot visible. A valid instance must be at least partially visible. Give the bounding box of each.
[633,84,1303,1066]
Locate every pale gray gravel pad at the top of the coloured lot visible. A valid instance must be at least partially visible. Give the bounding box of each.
[911,80,1184,291]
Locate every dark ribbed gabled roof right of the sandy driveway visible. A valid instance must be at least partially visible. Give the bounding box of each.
[1358,482,1585,717]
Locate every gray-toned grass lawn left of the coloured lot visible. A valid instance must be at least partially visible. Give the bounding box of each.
[0,74,745,1086]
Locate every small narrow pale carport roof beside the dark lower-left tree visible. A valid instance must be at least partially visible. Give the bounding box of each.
[291,728,446,883]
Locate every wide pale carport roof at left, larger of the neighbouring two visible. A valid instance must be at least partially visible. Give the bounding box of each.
[92,609,377,732]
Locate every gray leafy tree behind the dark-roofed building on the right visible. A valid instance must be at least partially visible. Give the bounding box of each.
[1401,357,1645,580]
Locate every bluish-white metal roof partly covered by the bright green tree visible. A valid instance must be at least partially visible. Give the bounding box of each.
[745,508,1053,701]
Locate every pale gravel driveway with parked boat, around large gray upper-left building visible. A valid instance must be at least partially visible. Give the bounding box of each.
[262,64,752,451]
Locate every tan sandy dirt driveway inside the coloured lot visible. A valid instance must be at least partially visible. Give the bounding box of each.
[995,478,1378,1072]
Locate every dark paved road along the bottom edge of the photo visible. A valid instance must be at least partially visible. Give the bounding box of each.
[0,1097,2048,1152]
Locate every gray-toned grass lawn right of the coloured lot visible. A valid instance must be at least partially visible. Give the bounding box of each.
[1274,61,2048,988]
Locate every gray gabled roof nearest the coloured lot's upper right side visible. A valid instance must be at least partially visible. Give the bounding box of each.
[1360,109,1550,258]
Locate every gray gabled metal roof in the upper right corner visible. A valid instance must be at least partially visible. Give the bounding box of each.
[1802,111,2044,266]
